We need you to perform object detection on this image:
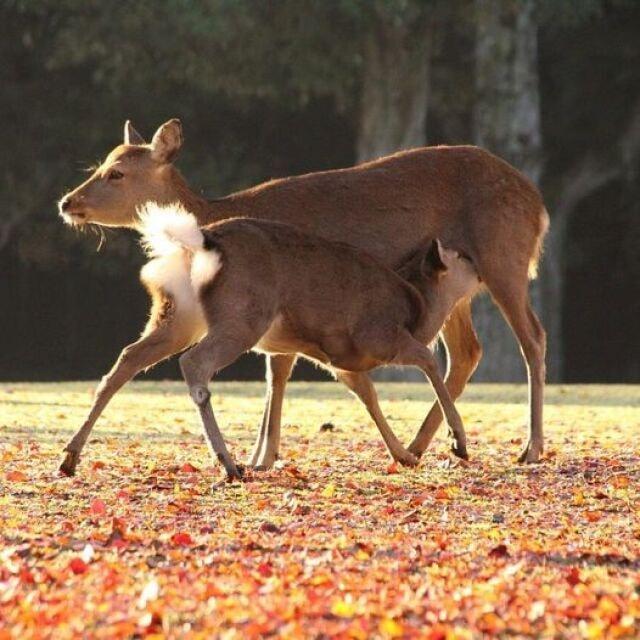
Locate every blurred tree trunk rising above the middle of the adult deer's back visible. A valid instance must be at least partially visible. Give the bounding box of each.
[356,5,434,162]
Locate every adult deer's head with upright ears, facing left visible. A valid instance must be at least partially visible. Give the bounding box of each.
[58,119,184,227]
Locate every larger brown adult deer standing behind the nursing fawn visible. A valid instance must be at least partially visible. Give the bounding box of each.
[59,119,549,474]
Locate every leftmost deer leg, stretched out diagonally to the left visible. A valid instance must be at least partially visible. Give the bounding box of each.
[60,306,190,476]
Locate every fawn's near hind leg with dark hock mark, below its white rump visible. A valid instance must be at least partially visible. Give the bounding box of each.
[180,334,253,480]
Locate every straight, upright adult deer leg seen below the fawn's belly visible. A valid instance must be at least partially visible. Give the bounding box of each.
[249,355,296,471]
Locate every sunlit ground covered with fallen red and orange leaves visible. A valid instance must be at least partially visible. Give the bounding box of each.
[0,382,640,640]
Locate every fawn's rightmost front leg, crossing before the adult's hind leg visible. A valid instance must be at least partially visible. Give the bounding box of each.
[394,333,468,460]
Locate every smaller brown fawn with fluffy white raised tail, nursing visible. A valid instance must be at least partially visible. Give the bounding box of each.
[140,203,479,479]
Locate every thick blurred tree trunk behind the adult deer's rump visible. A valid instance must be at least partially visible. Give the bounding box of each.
[473,0,561,382]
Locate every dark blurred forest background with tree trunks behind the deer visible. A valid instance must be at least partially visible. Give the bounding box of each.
[0,0,640,382]
